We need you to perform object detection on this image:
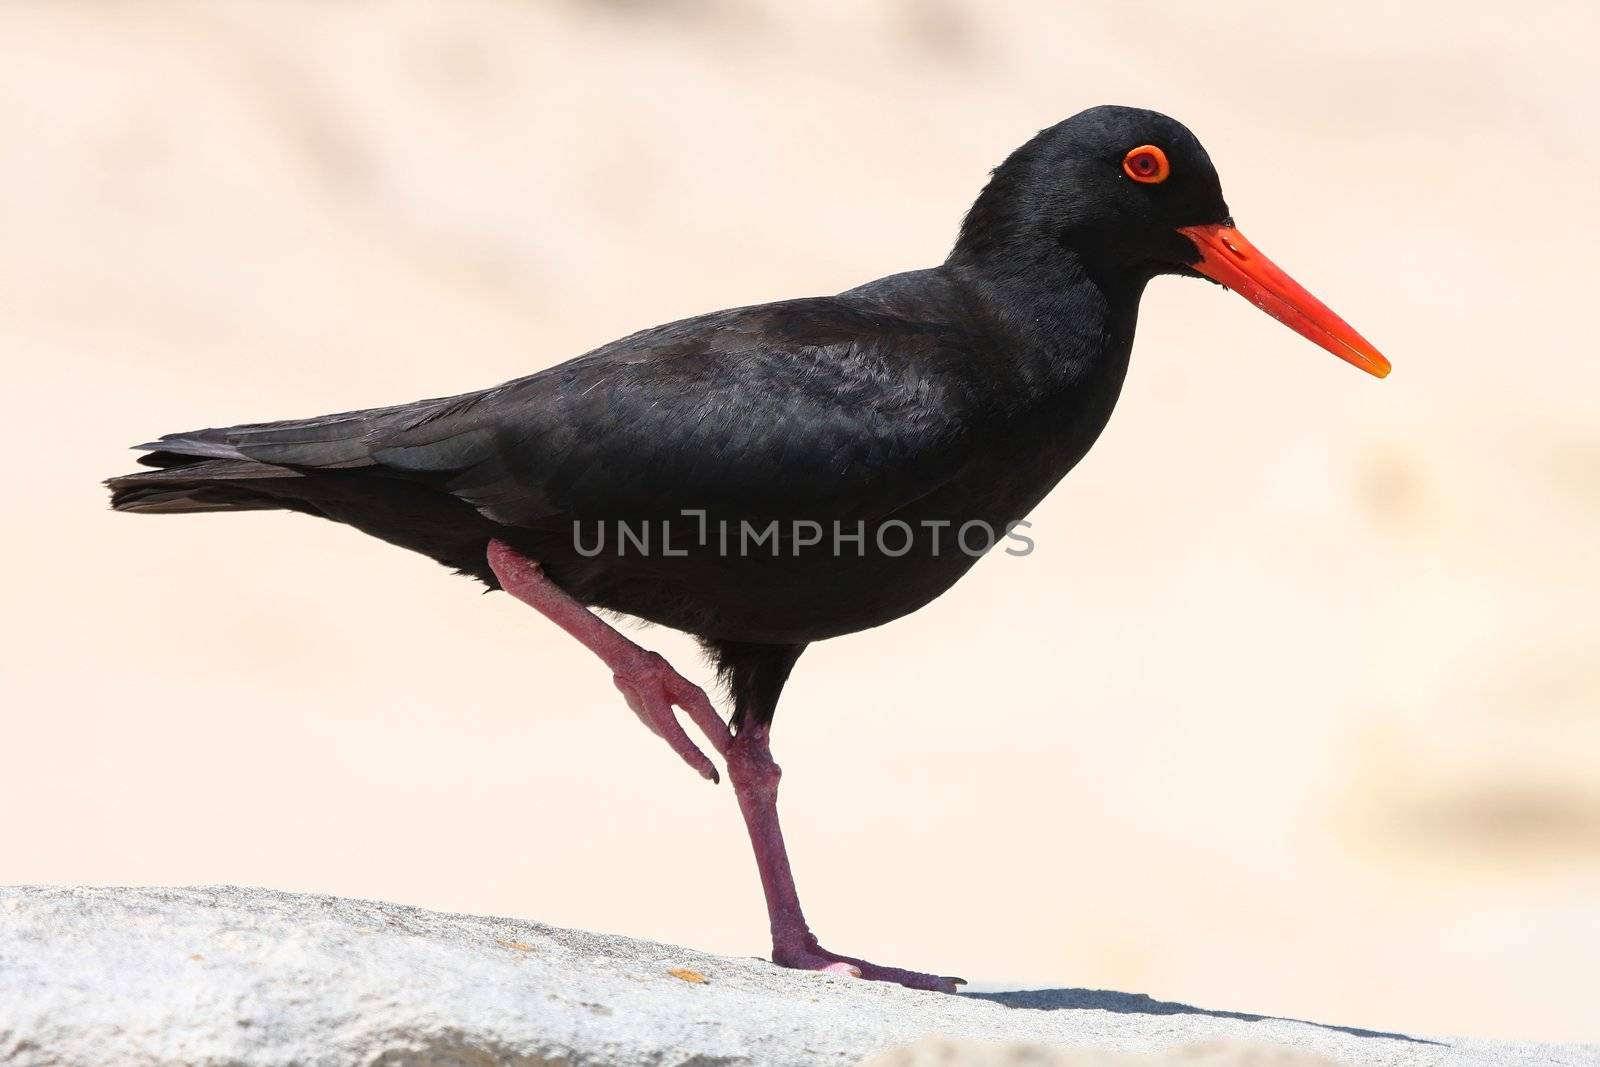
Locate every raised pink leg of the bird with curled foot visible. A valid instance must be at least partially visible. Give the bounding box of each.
[488,541,733,782]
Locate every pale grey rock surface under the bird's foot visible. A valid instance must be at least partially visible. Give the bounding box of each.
[0,886,1600,1067]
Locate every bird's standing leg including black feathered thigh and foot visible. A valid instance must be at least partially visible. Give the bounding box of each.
[723,646,962,993]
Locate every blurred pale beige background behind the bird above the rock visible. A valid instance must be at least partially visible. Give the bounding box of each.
[0,0,1600,1040]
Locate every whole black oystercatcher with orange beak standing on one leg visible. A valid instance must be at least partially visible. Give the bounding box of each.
[107,107,1389,990]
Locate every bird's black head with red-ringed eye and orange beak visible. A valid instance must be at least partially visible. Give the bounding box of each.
[955,106,1389,378]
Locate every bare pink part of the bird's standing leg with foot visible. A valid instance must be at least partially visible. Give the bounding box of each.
[726,723,962,993]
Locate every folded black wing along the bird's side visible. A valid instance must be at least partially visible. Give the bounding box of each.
[147,298,963,526]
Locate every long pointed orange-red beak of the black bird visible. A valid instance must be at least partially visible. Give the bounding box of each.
[1178,224,1389,378]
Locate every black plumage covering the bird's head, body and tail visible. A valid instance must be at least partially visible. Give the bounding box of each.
[109,109,1227,659]
